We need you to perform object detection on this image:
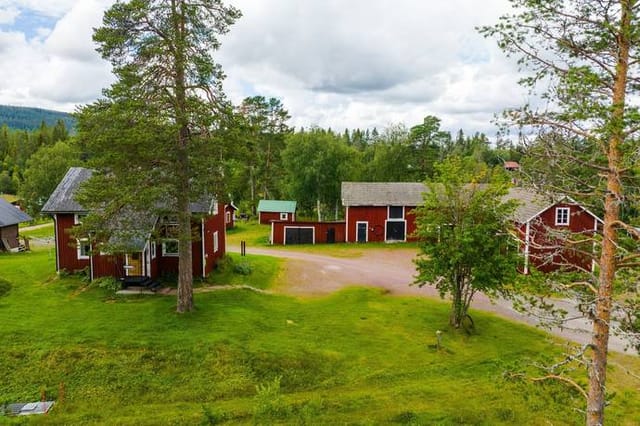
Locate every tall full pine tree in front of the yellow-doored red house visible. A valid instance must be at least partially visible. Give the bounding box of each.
[77,0,240,312]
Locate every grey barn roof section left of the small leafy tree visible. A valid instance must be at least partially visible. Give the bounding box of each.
[342,182,427,207]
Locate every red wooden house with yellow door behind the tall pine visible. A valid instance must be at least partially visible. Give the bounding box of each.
[42,167,226,281]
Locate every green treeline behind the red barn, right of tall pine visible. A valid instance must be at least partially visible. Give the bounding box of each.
[225,97,522,220]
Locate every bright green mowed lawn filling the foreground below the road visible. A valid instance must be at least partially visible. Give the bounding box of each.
[0,249,640,425]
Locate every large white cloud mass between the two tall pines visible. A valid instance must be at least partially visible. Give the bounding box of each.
[219,0,519,133]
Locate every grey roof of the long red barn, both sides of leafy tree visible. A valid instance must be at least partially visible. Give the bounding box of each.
[342,182,554,223]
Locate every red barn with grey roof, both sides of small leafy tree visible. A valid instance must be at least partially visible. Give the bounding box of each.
[342,182,601,273]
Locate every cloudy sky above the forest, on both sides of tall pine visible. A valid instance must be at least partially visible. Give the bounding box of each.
[0,0,525,134]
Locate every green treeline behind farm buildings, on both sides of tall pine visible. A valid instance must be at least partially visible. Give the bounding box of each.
[0,96,521,220]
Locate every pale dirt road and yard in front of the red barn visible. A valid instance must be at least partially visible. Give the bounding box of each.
[238,247,625,352]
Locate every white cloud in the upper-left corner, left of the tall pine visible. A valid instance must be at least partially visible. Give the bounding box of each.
[0,0,112,111]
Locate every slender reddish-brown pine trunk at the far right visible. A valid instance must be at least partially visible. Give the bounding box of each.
[587,0,632,426]
